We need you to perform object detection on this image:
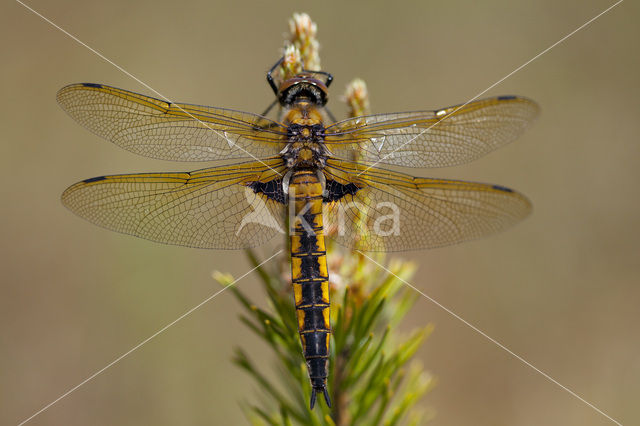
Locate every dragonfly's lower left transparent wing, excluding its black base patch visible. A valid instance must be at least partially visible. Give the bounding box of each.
[62,158,285,249]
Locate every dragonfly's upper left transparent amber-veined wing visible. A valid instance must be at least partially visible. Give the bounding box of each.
[57,83,287,161]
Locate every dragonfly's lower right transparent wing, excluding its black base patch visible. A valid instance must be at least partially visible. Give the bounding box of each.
[324,160,531,251]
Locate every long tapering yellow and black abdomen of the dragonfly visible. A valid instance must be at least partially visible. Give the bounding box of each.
[289,170,331,408]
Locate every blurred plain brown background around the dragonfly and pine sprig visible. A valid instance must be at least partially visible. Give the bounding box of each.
[0,0,640,425]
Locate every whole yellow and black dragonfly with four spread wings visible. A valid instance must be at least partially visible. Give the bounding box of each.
[57,59,539,409]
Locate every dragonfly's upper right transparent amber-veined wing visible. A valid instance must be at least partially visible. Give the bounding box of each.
[325,96,539,167]
